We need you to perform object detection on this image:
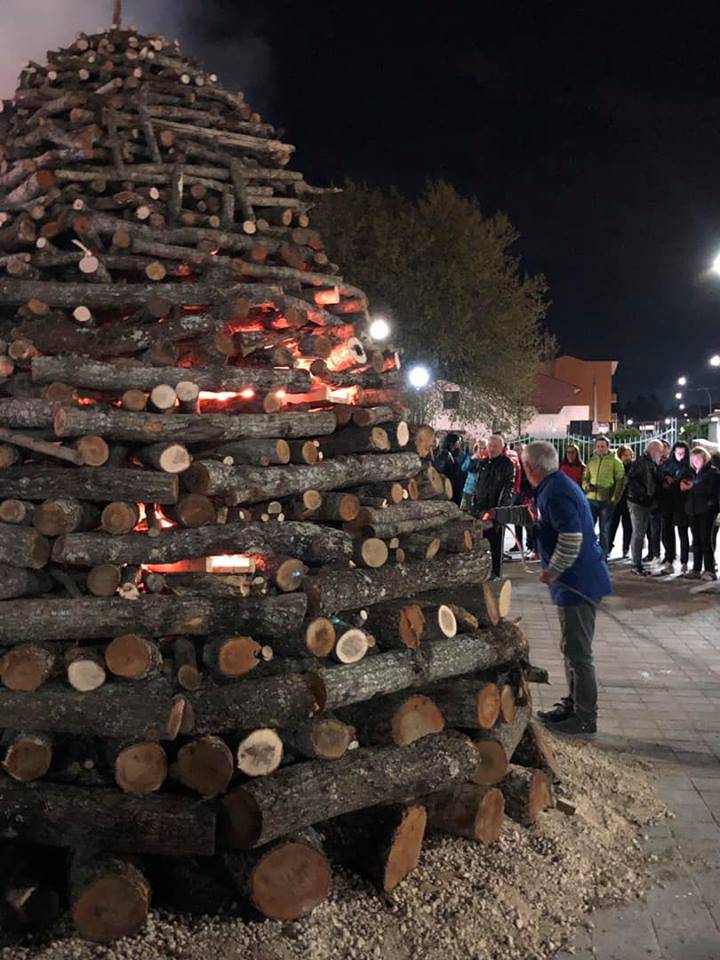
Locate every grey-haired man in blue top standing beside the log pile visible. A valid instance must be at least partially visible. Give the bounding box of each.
[523,441,611,737]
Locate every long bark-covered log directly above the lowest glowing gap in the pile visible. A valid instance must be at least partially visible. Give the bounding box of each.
[53,522,352,567]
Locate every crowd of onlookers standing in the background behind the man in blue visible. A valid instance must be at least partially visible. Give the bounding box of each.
[435,433,720,581]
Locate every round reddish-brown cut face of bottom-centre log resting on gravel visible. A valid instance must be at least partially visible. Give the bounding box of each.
[249,841,331,920]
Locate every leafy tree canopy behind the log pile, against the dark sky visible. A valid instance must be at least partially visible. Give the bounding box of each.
[316,182,548,423]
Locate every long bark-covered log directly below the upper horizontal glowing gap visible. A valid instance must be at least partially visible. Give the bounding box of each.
[55,401,338,448]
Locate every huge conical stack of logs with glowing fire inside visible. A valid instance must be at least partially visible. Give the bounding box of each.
[0,16,552,941]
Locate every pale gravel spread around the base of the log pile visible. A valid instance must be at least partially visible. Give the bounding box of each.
[0,744,668,960]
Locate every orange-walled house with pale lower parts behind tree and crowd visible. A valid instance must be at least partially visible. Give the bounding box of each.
[435,356,618,437]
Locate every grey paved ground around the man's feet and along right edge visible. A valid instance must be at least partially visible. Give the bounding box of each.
[504,562,720,960]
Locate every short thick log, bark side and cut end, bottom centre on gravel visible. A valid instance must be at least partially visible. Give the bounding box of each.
[224,829,331,921]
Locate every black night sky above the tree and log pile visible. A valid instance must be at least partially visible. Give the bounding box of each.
[3,0,720,402]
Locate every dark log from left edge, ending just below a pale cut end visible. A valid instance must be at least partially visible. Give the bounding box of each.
[0,466,179,504]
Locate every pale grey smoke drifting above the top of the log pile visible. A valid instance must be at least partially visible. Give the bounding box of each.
[0,0,273,110]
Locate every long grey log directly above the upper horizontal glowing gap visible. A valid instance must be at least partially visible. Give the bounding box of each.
[32,356,311,393]
